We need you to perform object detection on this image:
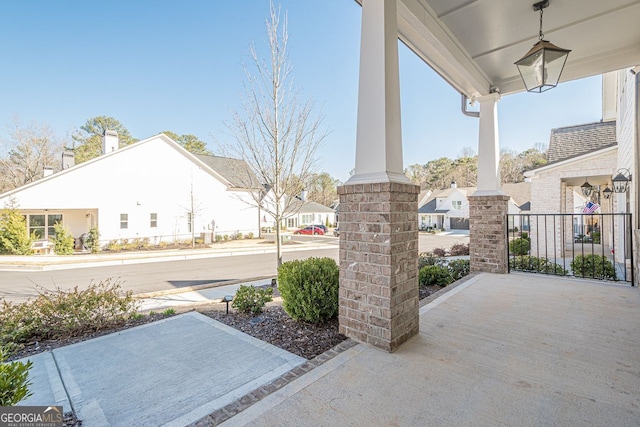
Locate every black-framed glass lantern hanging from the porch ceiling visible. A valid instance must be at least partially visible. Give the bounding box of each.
[515,0,571,93]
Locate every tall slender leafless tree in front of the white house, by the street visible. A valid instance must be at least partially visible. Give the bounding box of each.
[225,3,327,266]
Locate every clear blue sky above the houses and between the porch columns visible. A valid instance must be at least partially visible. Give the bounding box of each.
[0,0,602,181]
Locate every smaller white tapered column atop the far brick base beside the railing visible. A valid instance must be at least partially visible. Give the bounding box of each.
[473,93,503,196]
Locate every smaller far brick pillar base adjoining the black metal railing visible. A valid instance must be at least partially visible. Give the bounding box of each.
[469,195,510,274]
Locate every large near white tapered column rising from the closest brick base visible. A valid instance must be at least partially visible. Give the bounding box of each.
[346,0,410,184]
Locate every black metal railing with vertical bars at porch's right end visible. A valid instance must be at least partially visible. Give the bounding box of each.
[507,213,634,286]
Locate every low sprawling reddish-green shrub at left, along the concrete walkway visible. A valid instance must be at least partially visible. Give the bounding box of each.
[0,278,137,349]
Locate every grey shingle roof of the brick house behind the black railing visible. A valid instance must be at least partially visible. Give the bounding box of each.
[547,121,617,163]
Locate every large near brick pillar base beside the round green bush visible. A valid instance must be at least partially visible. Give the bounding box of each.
[338,182,420,352]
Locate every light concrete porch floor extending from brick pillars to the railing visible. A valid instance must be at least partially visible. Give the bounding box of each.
[224,274,640,426]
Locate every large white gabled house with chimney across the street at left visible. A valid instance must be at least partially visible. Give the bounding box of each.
[0,132,261,244]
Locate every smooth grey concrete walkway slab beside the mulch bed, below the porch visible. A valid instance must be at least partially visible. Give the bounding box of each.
[20,312,306,426]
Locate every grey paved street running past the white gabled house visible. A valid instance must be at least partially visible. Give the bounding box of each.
[0,233,469,301]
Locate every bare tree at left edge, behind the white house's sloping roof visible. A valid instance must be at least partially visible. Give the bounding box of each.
[0,118,62,193]
